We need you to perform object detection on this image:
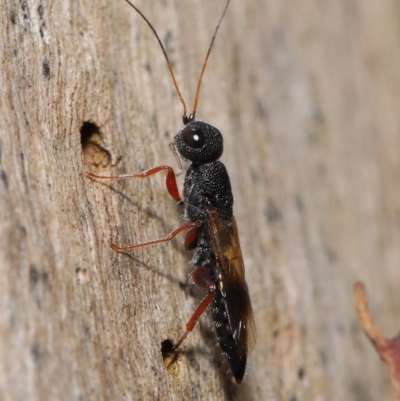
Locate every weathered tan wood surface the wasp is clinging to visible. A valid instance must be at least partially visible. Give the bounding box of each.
[0,0,400,401]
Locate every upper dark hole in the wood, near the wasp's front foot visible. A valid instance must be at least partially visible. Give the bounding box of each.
[80,121,111,170]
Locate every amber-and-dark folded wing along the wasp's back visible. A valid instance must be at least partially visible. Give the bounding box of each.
[208,207,256,354]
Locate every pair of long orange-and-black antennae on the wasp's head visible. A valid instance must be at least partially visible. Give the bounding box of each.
[125,0,231,125]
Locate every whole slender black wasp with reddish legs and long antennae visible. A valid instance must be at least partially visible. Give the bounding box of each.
[88,0,256,384]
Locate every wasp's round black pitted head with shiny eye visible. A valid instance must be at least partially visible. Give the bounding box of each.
[175,121,224,163]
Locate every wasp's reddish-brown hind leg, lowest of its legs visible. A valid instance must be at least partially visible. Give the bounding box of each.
[172,266,215,351]
